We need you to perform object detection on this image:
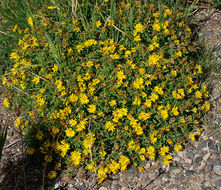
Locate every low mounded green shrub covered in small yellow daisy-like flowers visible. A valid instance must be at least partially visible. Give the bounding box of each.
[2,1,210,183]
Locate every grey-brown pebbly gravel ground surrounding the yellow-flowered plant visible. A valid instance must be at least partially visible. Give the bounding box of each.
[0,5,221,190]
